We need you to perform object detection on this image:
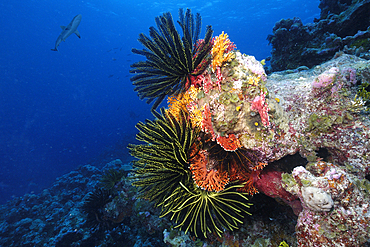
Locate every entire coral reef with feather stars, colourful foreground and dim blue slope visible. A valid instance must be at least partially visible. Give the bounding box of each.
[0,5,370,246]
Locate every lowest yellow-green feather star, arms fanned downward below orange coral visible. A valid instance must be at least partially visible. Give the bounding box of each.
[162,183,251,238]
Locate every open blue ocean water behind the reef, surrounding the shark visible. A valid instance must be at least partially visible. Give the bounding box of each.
[0,0,320,203]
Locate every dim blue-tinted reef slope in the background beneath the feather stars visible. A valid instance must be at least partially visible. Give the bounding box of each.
[0,157,295,247]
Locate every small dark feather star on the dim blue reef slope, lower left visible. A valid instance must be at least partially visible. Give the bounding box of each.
[81,188,113,230]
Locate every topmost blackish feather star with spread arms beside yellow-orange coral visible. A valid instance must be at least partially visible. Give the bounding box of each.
[130,9,213,110]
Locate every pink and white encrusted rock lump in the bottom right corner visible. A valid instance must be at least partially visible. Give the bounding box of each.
[283,161,370,247]
